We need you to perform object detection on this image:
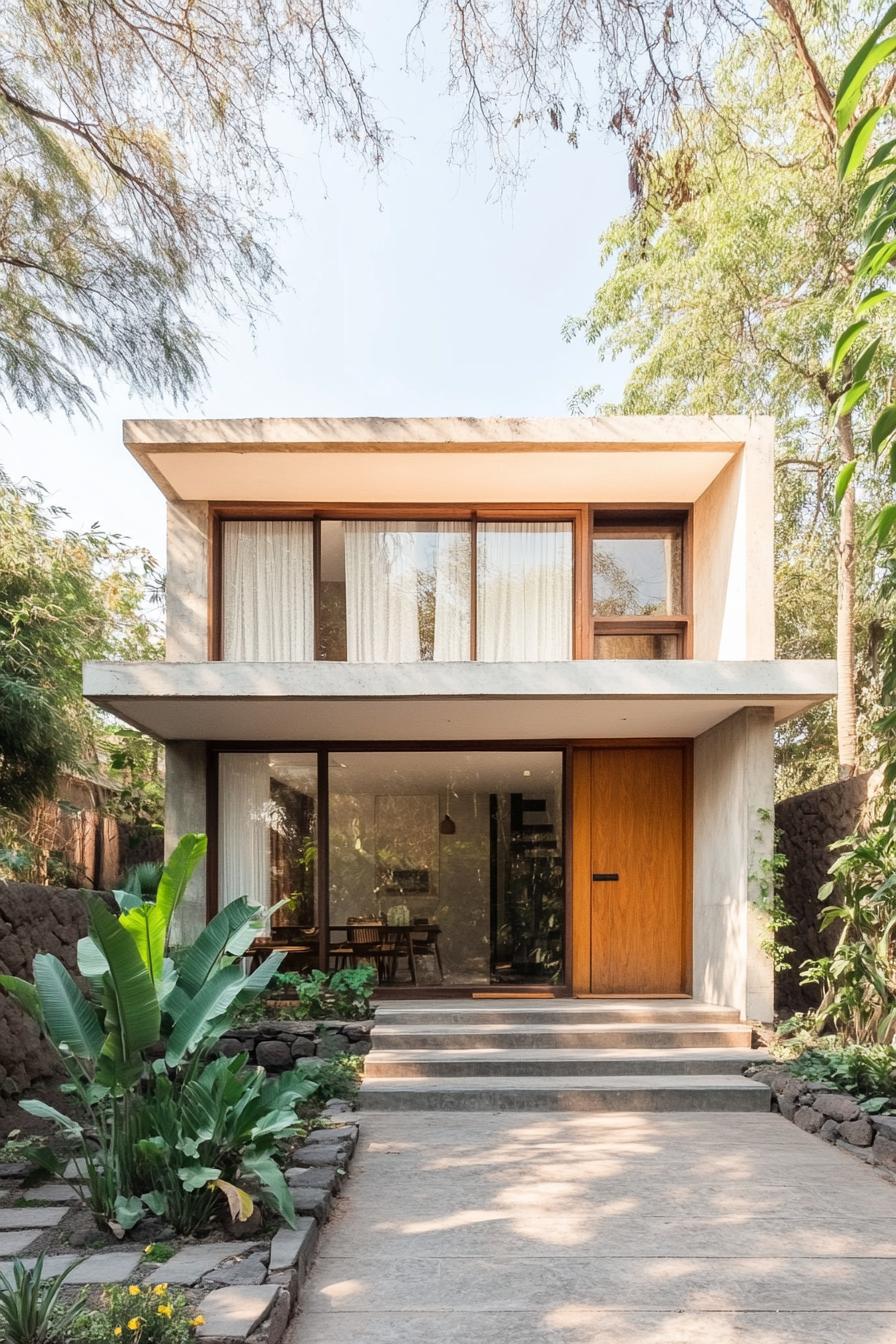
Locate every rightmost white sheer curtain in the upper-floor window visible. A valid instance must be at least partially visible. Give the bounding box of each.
[476,523,572,663]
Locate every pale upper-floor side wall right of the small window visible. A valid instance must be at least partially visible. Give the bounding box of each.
[692,417,775,659]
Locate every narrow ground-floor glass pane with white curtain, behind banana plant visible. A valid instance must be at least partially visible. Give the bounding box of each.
[218,751,318,969]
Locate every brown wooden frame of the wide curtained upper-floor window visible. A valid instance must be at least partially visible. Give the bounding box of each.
[208,501,594,663]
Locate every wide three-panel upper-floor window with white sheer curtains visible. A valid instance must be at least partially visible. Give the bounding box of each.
[220,516,574,663]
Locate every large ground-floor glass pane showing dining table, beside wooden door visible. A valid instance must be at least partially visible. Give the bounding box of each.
[329,751,564,985]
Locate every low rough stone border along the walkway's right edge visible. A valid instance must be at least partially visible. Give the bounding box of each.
[752,1066,896,1177]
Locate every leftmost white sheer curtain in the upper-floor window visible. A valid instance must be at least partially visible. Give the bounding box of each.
[222,521,314,663]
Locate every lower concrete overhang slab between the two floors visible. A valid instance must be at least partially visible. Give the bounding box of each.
[83,660,837,743]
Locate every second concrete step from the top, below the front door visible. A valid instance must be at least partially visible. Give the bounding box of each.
[368,1015,752,1058]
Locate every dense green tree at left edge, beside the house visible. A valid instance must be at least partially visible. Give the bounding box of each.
[0,473,160,814]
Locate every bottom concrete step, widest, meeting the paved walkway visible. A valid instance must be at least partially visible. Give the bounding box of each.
[360,1056,771,1111]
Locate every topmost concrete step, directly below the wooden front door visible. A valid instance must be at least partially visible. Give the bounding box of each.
[376,999,740,1028]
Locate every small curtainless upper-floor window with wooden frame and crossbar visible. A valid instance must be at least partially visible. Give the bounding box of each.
[591,513,688,659]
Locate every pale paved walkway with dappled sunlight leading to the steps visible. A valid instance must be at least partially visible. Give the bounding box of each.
[290,1111,896,1344]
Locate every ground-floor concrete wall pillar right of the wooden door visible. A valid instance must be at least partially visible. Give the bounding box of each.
[693,708,774,1021]
